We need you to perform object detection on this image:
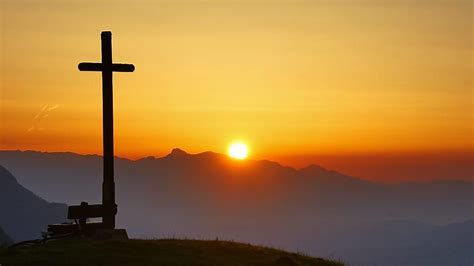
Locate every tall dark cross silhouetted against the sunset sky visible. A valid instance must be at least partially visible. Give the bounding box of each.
[78,31,135,229]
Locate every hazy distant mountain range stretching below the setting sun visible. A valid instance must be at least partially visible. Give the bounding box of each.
[0,149,474,265]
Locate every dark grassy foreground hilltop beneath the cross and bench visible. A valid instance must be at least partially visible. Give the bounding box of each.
[0,239,342,266]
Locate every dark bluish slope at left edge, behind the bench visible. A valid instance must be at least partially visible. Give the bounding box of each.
[0,165,67,241]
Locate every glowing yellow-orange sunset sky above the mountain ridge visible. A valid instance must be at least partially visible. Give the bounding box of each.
[0,0,474,180]
